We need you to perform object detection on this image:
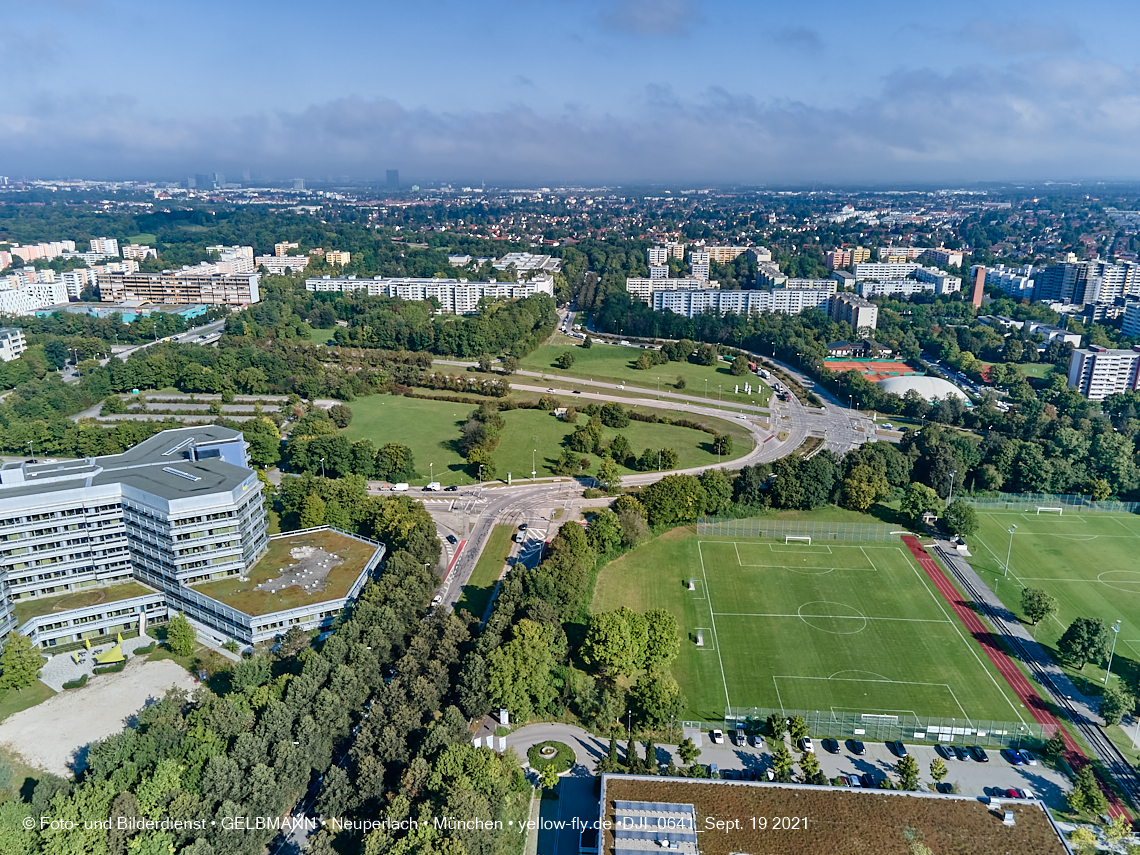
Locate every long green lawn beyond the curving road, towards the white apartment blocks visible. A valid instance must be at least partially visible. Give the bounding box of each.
[520,340,771,406]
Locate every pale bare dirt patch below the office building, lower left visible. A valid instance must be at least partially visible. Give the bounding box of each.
[0,659,196,777]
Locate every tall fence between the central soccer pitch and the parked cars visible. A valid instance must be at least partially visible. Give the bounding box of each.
[724,707,1057,748]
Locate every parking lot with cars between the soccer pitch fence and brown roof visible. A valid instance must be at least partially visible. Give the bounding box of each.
[700,733,1070,808]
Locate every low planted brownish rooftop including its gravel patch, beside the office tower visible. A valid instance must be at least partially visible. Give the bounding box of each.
[193,530,380,616]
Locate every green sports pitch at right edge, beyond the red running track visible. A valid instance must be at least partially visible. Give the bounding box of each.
[969,508,1140,694]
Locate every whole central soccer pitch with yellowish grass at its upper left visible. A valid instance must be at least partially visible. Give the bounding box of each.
[593,529,1033,722]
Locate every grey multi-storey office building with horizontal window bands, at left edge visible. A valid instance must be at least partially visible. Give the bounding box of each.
[0,425,268,641]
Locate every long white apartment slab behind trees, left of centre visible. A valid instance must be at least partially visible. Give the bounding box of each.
[304,272,554,315]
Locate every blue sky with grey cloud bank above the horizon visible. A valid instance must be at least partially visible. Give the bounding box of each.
[0,0,1140,186]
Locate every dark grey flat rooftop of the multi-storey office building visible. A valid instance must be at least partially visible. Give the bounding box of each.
[0,424,251,500]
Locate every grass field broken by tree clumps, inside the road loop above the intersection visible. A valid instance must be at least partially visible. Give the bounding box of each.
[344,394,752,485]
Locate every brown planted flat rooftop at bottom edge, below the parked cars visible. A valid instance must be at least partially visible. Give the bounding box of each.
[600,776,1066,855]
